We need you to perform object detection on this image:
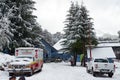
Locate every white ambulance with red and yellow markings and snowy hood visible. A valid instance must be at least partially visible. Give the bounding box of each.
[8,48,43,75]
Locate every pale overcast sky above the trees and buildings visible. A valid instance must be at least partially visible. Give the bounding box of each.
[34,0,120,35]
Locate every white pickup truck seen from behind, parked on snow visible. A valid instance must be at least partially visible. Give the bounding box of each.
[86,58,115,77]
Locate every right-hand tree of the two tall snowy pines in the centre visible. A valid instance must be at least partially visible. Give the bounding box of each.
[77,4,97,66]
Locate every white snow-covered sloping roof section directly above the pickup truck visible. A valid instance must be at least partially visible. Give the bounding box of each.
[87,47,116,58]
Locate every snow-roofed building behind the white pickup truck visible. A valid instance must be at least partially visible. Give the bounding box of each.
[87,42,120,59]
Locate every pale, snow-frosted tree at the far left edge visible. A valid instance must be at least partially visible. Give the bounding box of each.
[0,0,13,50]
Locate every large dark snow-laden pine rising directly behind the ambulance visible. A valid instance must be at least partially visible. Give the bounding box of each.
[5,0,40,46]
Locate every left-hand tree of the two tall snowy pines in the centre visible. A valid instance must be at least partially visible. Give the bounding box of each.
[63,2,76,47]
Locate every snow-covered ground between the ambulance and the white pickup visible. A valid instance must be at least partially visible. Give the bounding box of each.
[0,62,120,80]
